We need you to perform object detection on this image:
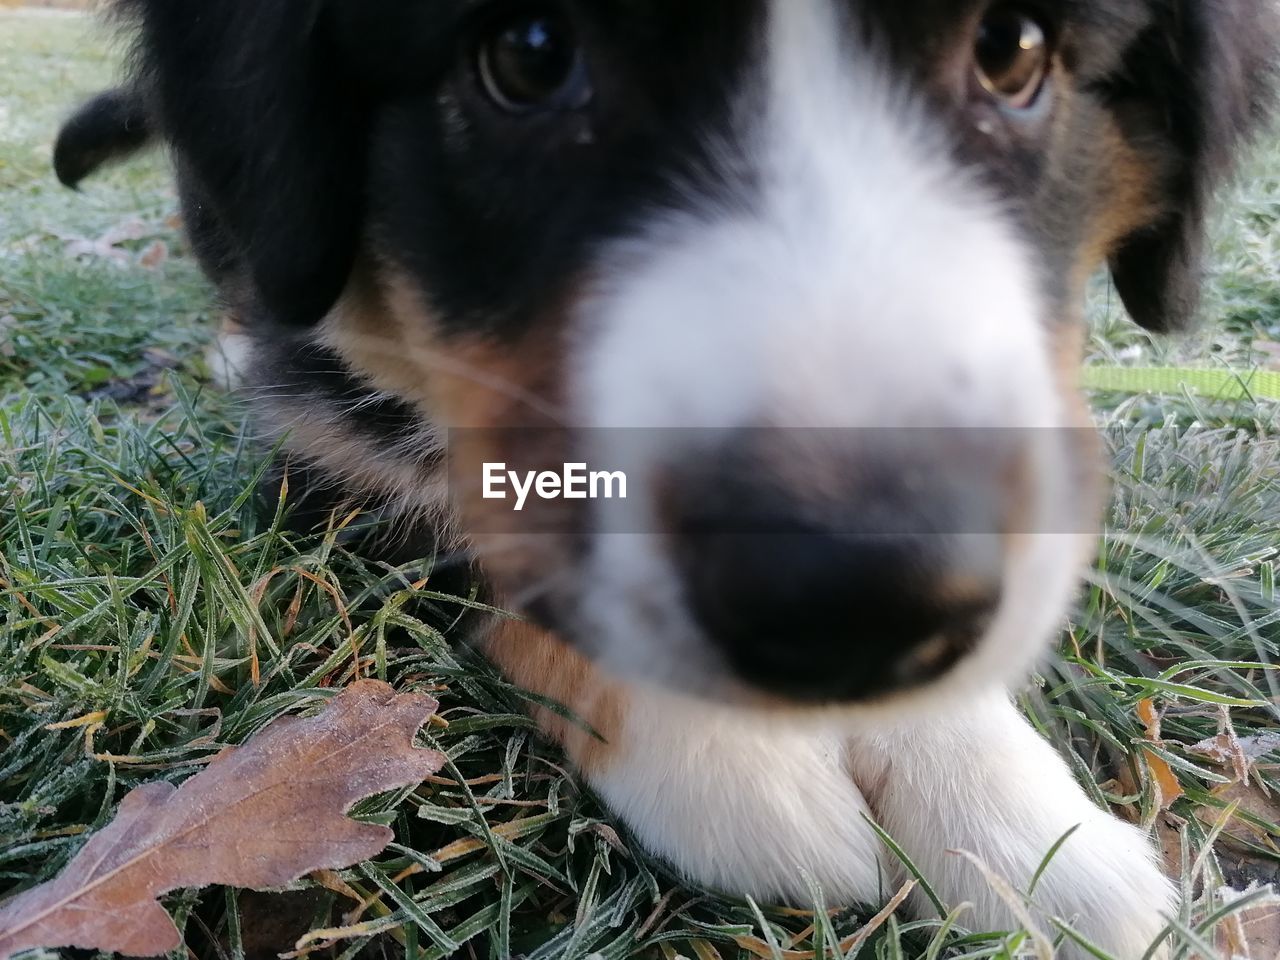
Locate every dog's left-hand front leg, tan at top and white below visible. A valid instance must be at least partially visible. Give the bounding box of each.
[488,625,893,906]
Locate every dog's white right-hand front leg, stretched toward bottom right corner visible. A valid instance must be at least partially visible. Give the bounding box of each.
[854,692,1175,960]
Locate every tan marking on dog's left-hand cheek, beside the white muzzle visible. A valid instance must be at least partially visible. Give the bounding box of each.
[320,266,575,599]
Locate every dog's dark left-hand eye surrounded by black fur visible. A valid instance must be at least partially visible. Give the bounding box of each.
[476,12,591,113]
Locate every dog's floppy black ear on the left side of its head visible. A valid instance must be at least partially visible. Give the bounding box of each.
[129,0,367,324]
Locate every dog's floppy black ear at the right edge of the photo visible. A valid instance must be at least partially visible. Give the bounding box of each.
[1108,0,1280,332]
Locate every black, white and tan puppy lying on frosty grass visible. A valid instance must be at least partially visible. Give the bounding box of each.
[55,0,1276,957]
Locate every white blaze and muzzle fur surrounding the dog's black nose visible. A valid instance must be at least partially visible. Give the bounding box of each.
[573,0,1084,705]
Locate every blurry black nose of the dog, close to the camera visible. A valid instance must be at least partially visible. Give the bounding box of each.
[675,450,1005,701]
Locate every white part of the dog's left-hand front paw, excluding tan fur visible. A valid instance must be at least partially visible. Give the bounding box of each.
[586,694,888,906]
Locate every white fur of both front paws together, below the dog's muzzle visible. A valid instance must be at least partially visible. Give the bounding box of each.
[590,687,1176,960]
